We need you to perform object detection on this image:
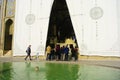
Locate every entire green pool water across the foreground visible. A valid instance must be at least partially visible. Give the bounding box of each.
[0,62,120,80]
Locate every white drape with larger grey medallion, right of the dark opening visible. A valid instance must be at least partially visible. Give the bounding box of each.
[67,0,120,56]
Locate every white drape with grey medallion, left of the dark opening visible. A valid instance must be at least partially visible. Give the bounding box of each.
[13,0,53,55]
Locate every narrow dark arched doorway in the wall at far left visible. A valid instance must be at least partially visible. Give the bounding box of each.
[4,19,13,50]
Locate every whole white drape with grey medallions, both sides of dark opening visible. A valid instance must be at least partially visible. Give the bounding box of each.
[13,0,120,56]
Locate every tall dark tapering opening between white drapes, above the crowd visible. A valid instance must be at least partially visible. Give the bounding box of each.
[46,0,77,45]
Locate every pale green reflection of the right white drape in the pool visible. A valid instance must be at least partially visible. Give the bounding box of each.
[77,65,120,80]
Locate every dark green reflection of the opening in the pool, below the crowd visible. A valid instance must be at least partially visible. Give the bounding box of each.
[46,63,79,80]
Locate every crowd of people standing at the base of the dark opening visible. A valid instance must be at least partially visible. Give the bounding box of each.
[46,45,78,61]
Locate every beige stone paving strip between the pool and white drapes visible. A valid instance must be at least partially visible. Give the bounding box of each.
[0,56,120,69]
